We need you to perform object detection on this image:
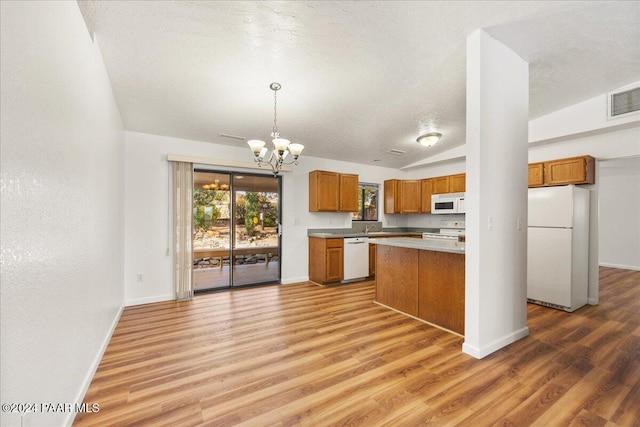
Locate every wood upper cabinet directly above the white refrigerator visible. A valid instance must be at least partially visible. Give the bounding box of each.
[528,156,596,187]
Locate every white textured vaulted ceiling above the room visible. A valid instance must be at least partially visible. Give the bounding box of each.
[79,0,640,167]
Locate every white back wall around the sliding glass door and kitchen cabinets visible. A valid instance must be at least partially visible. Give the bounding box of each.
[124,132,406,305]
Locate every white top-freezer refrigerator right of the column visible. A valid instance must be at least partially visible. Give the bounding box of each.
[527,185,589,312]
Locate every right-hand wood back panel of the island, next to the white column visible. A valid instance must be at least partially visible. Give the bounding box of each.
[418,251,465,335]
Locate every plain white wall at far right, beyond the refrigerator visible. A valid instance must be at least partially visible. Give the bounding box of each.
[598,156,640,270]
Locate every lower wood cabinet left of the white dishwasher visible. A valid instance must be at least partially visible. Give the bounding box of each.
[309,237,344,284]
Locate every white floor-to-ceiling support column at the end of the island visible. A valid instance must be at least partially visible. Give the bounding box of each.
[462,29,529,358]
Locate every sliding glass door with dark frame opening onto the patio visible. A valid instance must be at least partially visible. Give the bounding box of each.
[193,169,281,292]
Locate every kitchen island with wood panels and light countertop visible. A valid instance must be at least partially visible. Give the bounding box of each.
[369,237,465,335]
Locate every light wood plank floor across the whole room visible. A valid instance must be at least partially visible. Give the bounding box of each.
[74,268,640,426]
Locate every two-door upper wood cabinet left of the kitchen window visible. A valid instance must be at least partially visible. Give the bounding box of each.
[309,170,358,212]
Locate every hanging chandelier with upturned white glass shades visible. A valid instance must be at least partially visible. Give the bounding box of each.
[247,82,304,176]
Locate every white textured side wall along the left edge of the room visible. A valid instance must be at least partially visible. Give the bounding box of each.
[0,1,124,426]
